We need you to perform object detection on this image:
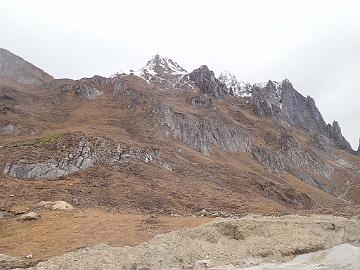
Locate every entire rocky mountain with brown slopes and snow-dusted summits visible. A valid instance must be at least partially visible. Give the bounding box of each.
[0,47,360,213]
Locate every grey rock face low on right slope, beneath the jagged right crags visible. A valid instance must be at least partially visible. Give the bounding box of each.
[252,134,331,191]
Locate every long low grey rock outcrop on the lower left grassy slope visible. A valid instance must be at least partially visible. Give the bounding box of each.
[4,137,172,180]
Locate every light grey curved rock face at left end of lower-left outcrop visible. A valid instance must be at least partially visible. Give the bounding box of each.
[4,140,98,180]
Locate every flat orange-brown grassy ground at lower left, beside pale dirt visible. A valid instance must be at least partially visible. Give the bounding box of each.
[0,209,213,261]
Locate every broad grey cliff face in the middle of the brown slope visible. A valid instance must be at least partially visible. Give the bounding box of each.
[154,105,251,156]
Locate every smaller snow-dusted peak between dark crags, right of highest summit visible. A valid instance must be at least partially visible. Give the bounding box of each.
[218,71,251,97]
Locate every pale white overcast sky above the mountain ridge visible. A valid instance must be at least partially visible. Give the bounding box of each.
[0,0,360,149]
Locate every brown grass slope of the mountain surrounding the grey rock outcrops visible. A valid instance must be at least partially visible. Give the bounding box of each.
[0,61,360,217]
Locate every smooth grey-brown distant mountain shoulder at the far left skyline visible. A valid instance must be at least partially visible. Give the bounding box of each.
[0,48,54,85]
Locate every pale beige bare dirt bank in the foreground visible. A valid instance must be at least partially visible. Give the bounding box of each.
[24,215,360,270]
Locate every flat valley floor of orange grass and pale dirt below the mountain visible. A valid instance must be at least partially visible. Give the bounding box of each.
[0,207,360,270]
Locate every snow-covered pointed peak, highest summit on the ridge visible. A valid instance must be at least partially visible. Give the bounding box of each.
[140,54,187,75]
